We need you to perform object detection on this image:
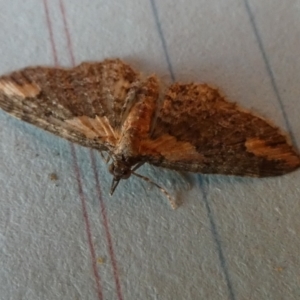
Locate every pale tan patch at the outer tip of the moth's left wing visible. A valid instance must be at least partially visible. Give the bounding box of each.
[0,80,41,98]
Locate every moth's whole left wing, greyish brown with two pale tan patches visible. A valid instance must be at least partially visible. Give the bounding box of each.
[0,59,139,150]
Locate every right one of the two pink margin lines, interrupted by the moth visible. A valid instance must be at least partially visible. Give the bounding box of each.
[59,0,123,300]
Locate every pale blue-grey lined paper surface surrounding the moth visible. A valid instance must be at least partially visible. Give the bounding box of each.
[0,0,300,300]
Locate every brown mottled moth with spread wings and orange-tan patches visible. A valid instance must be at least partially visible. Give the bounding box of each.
[0,59,300,206]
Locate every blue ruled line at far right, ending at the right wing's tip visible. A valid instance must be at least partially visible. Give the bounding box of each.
[243,0,297,145]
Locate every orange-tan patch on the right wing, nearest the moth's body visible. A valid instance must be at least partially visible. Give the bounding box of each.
[139,134,204,162]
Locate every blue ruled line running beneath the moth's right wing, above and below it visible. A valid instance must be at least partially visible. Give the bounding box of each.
[150,0,236,300]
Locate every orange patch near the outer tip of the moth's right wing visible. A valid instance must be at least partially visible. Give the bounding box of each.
[245,138,299,165]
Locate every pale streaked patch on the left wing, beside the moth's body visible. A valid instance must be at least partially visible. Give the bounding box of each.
[66,116,119,145]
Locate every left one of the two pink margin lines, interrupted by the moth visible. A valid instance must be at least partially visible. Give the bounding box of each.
[43,0,103,300]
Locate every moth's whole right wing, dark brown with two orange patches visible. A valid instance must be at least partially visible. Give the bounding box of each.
[140,83,300,177]
